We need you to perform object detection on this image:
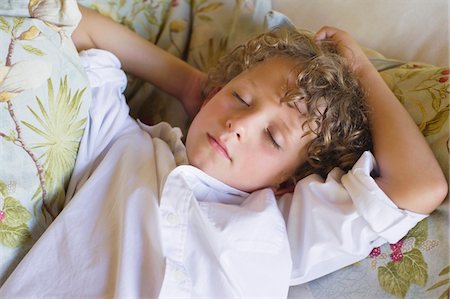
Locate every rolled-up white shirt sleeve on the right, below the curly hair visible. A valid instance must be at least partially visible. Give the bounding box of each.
[279,152,427,285]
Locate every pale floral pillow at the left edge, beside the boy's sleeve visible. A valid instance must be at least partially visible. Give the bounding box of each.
[0,0,90,285]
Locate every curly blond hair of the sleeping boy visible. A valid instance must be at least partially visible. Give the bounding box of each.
[202,29,371,181]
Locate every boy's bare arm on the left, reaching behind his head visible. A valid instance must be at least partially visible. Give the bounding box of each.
[72,5,206,117]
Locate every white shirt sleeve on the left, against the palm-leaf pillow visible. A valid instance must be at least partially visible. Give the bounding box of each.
[66,49,139,199]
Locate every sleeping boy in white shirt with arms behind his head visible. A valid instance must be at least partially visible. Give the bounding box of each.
[0,2,447,298]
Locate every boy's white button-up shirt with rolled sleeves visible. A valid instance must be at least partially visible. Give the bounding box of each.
[0,50,425,298]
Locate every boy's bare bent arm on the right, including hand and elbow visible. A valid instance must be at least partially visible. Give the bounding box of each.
[316,27,448,214]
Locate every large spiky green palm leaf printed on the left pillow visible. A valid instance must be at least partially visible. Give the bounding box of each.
[22,76,86,218]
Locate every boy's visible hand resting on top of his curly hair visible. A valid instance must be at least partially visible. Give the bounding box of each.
[315,26,372,74]
